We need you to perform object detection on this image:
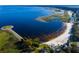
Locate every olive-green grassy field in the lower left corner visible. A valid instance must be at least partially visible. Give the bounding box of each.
[0,30,19,52]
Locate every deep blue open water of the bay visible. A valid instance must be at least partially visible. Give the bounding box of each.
[0,6,63,36]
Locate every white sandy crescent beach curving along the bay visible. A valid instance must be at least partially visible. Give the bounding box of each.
[42,23,73,46]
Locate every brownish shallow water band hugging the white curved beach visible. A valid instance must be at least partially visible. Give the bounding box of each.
[40,23,67,42]
